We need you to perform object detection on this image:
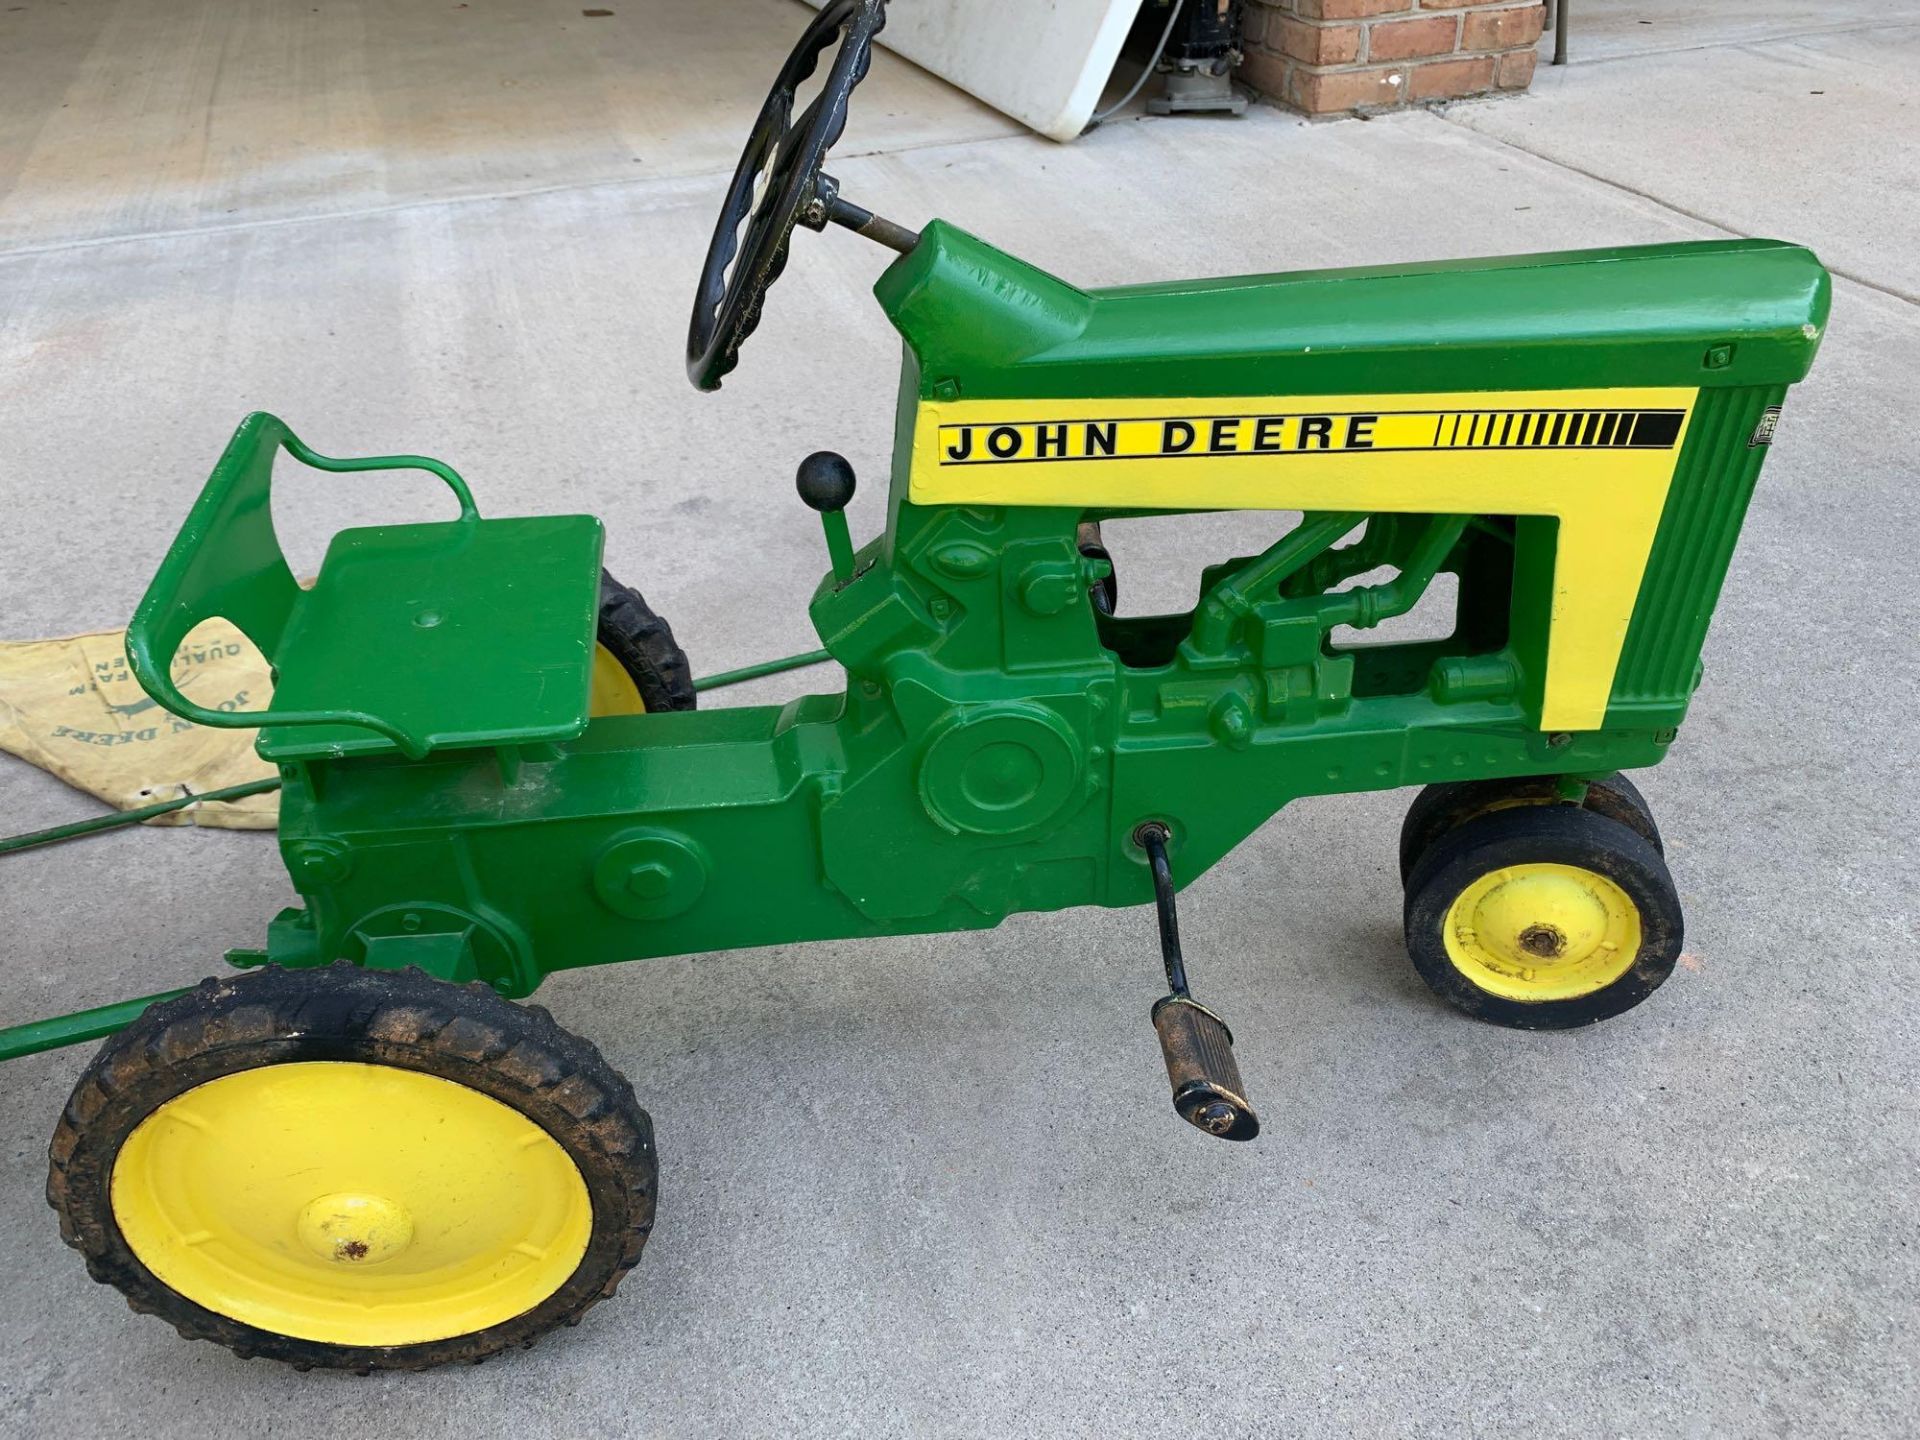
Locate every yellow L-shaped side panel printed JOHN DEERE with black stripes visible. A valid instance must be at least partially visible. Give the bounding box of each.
[908,388,1697,730]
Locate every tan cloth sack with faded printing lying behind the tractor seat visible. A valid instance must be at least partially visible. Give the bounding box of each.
[0,620,280,829]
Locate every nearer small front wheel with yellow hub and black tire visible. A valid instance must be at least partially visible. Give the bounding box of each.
[1405,804,1682,1029]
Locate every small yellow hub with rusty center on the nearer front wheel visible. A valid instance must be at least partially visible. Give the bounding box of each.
[1444,864,1640,1002]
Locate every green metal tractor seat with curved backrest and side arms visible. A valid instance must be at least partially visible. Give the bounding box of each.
[127,413,603,762]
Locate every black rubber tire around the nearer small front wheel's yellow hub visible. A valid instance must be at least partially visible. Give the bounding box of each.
[1404,804,1684,1029]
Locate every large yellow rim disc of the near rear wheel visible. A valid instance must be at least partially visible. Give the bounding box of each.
[111,1060,593,1346]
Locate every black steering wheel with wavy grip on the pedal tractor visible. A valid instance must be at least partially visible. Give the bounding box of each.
[687,0,887,390]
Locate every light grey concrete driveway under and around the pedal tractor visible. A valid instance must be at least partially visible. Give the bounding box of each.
[0,0,1920,1440]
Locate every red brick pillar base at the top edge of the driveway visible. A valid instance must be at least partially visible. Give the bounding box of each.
[1238,0,1546,115]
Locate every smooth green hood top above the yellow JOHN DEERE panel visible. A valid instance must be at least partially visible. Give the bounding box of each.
[874,221,1832,399]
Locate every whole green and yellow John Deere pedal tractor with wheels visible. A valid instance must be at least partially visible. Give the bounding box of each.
[15,0,1830,1371]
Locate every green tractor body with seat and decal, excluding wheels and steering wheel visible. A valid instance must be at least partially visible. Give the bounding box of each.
[112,223,1830,995]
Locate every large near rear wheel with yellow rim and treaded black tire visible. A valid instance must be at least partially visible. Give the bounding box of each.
[46,964,655,1371]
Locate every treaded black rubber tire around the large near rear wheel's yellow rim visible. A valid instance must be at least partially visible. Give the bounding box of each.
[46,962,657,1375]
